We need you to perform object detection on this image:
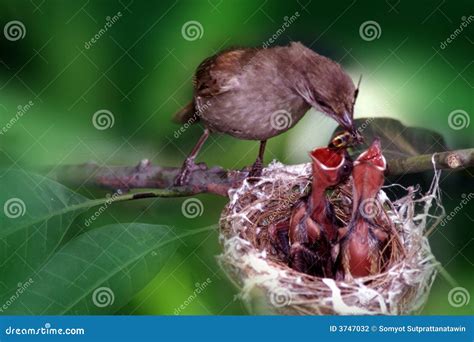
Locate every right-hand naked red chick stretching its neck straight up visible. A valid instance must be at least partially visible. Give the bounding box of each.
[341,139,387,277]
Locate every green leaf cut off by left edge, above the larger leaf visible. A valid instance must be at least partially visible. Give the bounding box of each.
[0,169,90,298]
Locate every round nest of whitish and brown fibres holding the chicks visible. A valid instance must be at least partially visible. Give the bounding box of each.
[218,162,442,315]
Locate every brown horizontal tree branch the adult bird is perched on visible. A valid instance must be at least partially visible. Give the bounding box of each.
[54,148,474,198]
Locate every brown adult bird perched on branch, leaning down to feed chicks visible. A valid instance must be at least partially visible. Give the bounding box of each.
[174,42,358,185]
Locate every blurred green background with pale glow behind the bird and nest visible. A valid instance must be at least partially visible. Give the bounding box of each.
[0,0,474,314]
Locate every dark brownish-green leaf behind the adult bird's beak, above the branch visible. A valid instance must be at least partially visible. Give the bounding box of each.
[333,118,447,160]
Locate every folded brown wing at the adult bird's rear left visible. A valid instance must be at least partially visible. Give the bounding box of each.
[194,49,255,97]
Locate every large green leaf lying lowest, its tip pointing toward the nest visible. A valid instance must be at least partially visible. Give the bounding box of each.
[3,223,187,315]
